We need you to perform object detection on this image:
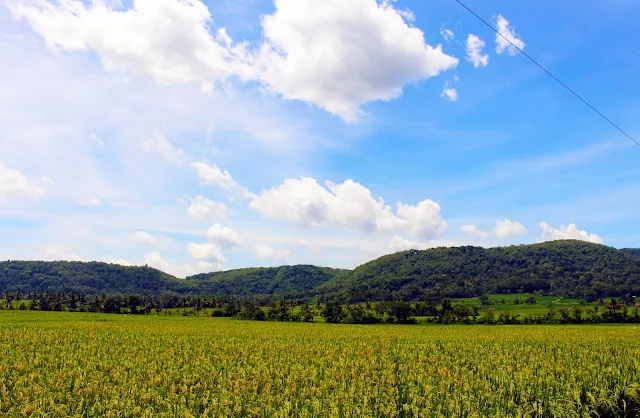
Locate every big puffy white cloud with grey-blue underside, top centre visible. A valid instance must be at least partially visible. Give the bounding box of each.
[257,0,458,121]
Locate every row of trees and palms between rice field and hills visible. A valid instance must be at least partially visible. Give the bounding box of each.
[7,291,640,325]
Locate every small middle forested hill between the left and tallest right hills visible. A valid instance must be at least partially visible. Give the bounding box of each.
[187,265,344,298]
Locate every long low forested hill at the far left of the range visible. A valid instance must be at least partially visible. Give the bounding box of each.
[0,261,196,295]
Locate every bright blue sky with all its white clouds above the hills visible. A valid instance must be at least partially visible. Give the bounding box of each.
[0,0,640,277]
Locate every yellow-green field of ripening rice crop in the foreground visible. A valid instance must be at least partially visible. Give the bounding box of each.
[0,311,640,417]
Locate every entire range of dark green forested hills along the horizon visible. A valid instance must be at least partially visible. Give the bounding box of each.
[0,241,640,303]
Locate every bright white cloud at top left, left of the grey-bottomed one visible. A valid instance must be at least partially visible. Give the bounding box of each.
[9,0,249,84]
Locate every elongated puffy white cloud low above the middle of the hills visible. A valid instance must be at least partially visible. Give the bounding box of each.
[250,177,447,240]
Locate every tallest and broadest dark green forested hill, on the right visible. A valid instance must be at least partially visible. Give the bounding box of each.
[317,241,640,302]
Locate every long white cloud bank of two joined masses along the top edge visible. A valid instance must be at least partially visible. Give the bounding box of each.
[10,0,458,121]
